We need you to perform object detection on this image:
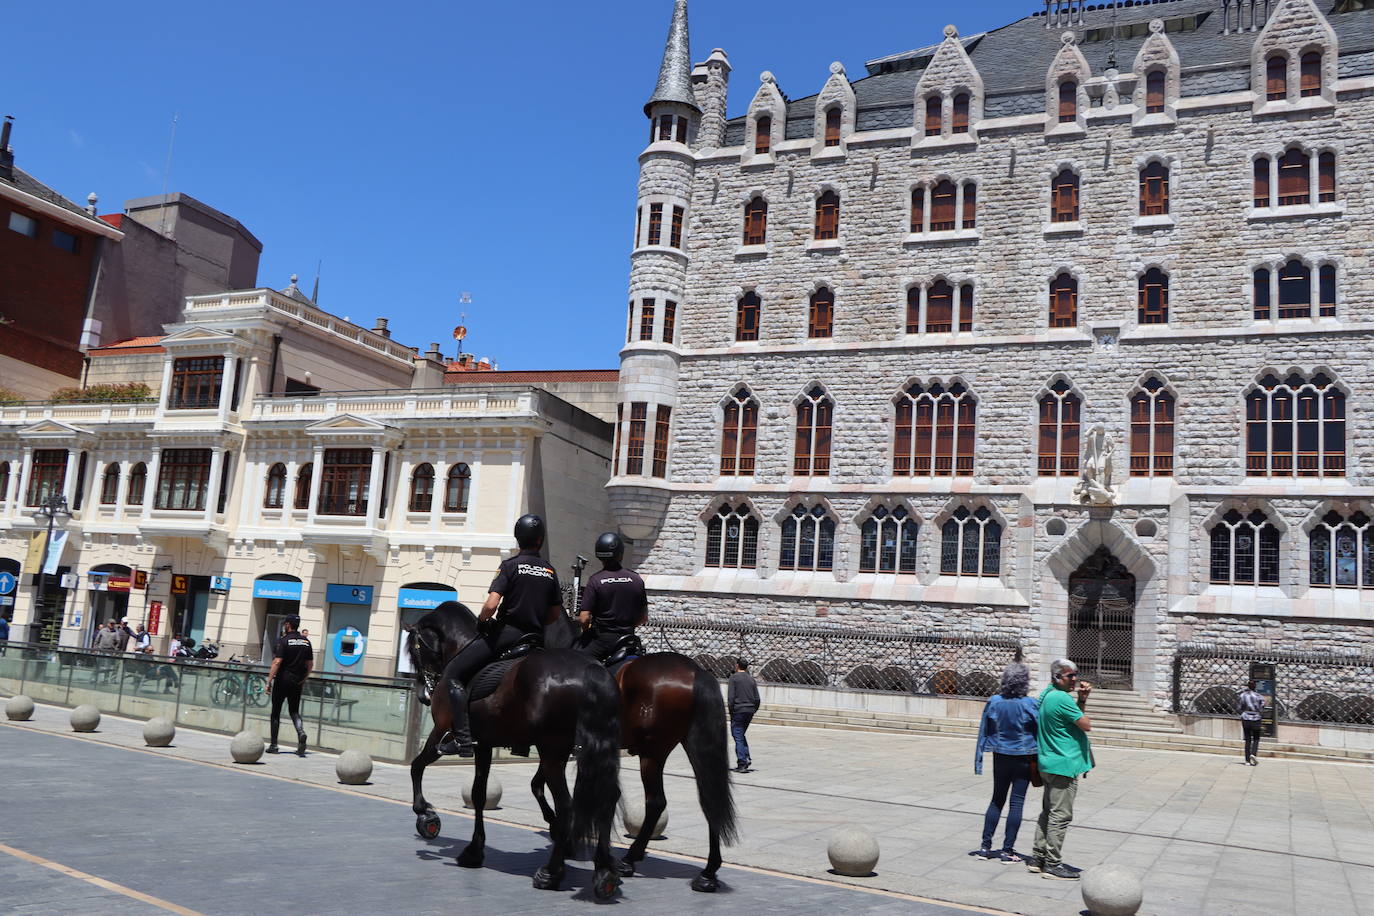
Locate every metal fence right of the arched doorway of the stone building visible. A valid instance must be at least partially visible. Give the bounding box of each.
[1173,645,1374,725]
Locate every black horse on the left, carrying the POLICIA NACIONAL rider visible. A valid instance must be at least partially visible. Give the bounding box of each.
[405,602,620,900]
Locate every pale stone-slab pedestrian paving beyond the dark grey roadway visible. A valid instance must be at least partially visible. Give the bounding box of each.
[0,706,1374,916]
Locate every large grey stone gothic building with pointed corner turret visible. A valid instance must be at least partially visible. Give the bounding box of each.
[609,0,1374,705]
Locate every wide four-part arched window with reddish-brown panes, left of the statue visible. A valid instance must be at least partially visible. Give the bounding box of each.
[892,382,978,477]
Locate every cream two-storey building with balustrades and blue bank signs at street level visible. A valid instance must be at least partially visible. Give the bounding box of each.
[0,284,611,674]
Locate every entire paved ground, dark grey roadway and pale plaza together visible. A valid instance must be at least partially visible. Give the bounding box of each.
[0,707,1374,916]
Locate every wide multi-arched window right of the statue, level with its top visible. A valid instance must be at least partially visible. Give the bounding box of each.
[1245,372,1345,477]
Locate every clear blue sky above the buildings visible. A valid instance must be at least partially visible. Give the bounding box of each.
[13,0,1036,369]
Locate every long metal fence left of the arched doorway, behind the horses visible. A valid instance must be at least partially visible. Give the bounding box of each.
[639,618,1021,698]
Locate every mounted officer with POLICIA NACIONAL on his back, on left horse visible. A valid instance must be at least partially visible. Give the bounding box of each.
[438,515,563,757]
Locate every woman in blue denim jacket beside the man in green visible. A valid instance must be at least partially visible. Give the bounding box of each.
[969,662,1041,862]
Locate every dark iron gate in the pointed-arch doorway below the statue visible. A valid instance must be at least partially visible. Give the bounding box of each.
[1069,547,1135,689]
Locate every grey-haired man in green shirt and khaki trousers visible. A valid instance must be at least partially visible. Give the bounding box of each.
[1026,658,1092,880]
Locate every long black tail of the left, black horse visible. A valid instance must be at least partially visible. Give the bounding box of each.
[569,663,620,843]
